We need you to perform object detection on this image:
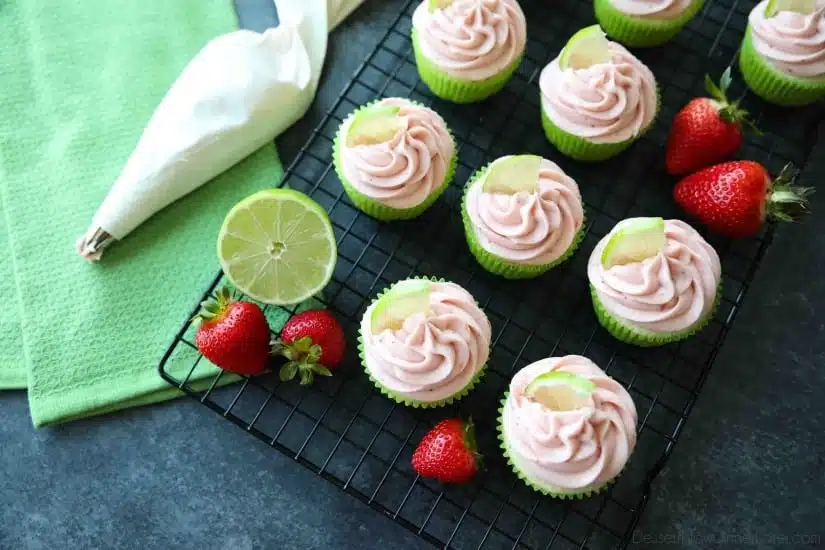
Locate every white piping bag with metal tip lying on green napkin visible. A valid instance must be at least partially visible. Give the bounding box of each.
[76,0,363,261]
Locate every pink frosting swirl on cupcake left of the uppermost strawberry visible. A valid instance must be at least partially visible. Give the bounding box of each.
[539,42,658,143]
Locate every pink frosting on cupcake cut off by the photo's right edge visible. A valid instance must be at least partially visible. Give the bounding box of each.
[748,0,825,78]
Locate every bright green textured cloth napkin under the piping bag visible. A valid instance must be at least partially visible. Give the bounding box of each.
[0,0,282,426]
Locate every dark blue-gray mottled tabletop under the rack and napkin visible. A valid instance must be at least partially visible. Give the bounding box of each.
[0,0,825,550]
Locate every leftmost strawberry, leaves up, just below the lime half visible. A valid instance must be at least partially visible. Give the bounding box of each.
[194,287,270,375]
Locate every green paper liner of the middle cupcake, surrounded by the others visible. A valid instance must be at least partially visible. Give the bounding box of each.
[461,163,586,279]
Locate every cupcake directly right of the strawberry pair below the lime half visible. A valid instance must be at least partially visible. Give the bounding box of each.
[359,279,492,407]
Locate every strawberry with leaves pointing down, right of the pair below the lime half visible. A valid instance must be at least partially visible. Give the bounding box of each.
[272,309,347,385]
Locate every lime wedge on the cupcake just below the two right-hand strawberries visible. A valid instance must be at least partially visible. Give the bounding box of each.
[602,218,666,269]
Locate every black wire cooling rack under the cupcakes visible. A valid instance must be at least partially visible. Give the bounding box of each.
[160,0,822,550]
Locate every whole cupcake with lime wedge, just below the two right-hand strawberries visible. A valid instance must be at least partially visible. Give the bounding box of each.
[587,218,722,346]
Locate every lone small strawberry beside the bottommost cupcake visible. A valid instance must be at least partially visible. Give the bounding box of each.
[412,418,481,483]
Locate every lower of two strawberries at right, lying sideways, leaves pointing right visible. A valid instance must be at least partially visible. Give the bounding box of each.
[673,160,812,237]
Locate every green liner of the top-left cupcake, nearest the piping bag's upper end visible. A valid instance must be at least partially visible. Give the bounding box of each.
[412,29,523,103]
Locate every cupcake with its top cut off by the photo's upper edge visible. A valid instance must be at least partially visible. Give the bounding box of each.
[594,0,705,48]
